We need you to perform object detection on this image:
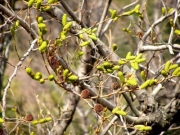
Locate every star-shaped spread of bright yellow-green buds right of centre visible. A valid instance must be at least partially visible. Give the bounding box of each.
[118,52,146,70]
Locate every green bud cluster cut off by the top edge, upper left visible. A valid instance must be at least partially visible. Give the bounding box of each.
[28,0,50,12]
